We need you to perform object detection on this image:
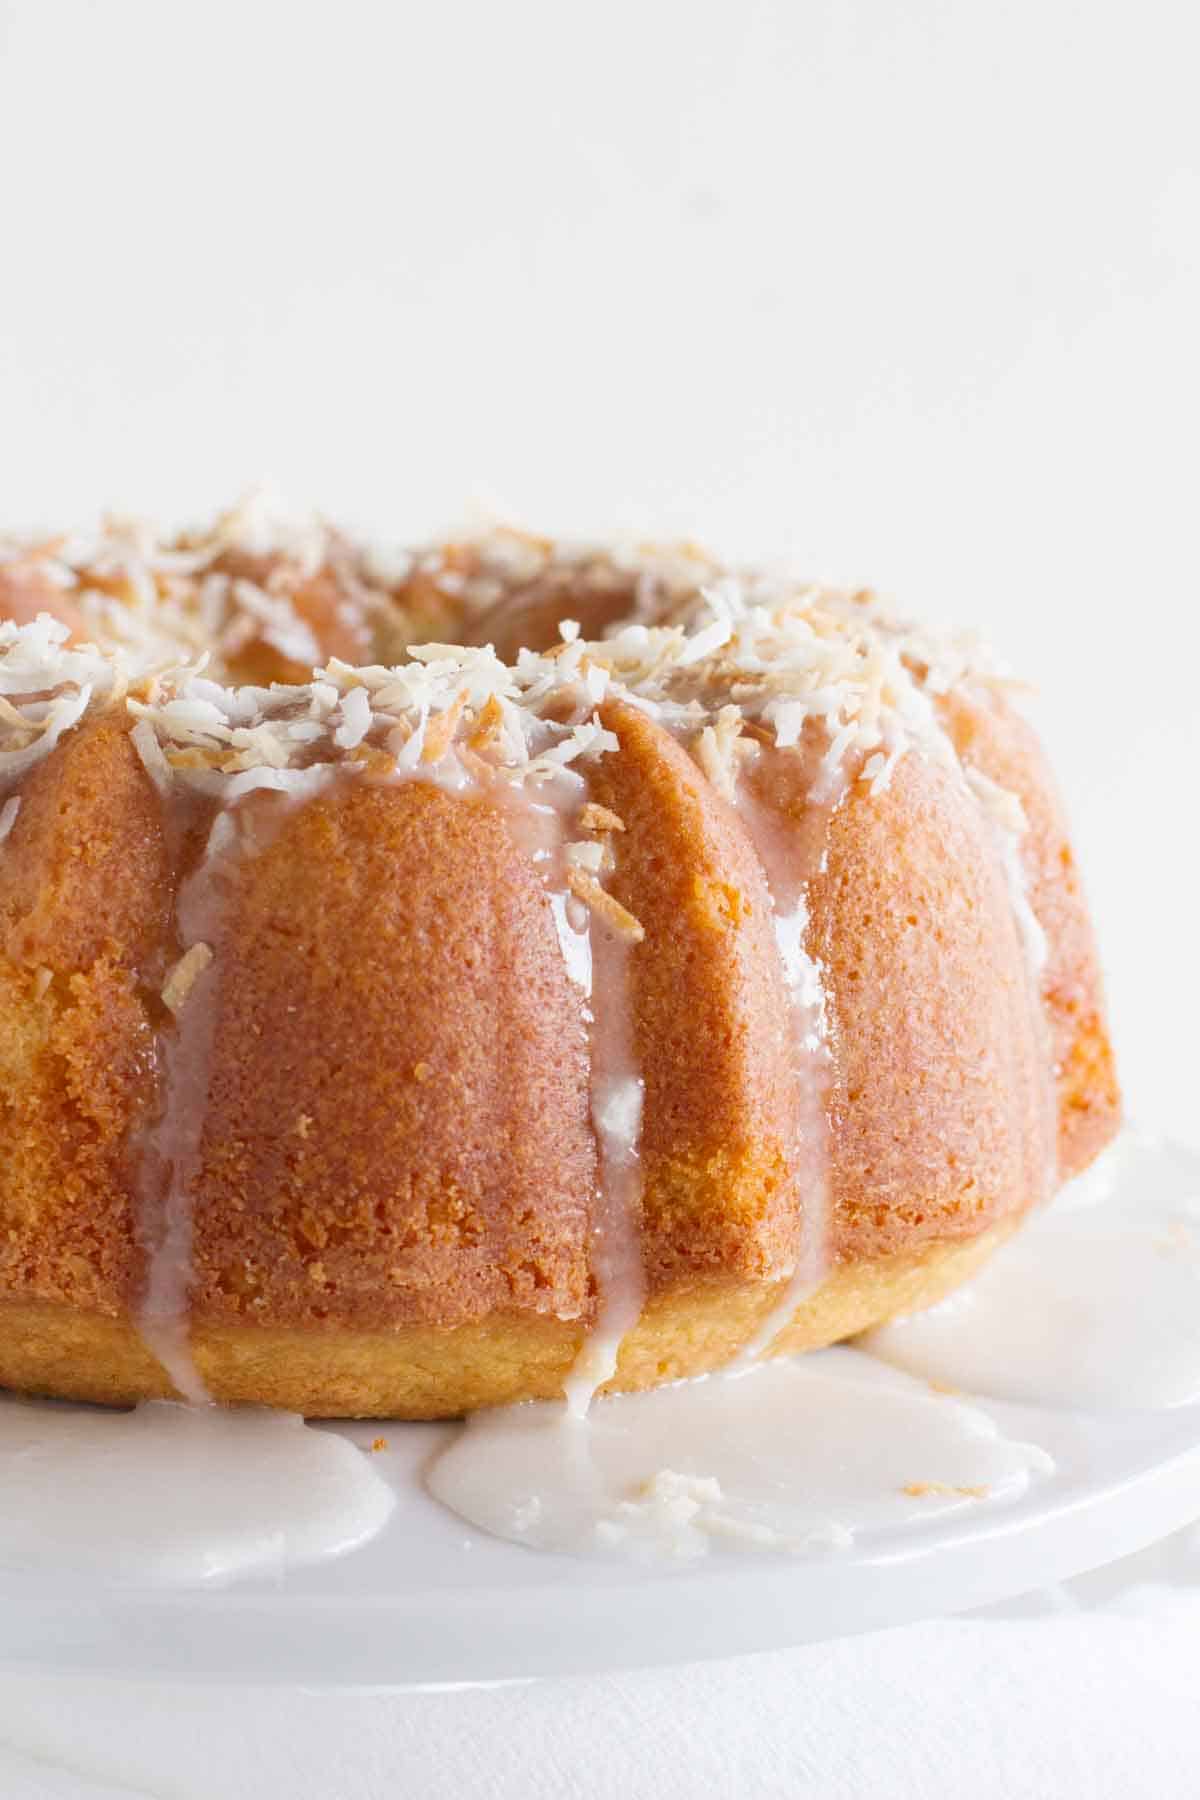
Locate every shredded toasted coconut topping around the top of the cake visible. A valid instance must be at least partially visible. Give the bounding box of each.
[0,493,991,817]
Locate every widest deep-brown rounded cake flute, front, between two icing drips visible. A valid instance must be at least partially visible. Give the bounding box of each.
[193,781,596,1328]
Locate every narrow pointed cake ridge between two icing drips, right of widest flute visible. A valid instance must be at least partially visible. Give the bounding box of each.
[592,704,804,1292]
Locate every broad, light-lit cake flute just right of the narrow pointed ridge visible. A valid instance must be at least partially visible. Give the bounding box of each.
[810,758,1049,1260]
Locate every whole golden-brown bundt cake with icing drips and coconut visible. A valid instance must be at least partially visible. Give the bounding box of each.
[0,502,1119,1418]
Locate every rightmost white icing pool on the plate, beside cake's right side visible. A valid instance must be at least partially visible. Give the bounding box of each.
[862,1145,1200,1411]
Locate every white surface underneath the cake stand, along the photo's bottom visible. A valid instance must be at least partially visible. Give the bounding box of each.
[0,1532,1200,1800]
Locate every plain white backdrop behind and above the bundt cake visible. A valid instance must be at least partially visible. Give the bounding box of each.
[0,0,1200,1795]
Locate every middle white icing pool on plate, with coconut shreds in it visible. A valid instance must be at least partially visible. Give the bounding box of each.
[426,1350,1052,1562]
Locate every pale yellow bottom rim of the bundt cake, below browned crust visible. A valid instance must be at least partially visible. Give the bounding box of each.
[0,1226,1007,1418]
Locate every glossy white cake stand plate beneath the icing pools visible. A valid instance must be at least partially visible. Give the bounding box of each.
[0,1404,1200,1688]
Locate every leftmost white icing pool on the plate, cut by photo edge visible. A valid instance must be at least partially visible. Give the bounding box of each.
[0,1399,396,1586]
